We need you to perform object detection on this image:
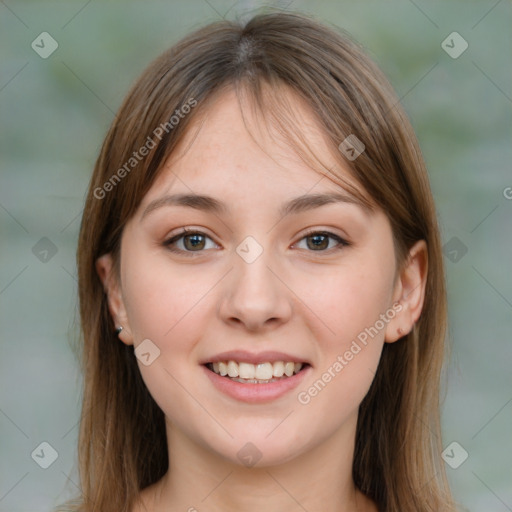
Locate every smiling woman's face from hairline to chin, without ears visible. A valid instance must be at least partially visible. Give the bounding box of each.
[99,87,412,465]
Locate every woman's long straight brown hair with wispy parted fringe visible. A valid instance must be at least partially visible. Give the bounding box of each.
[71,14,455,512]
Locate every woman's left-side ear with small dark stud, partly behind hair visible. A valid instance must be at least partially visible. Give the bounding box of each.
[96,254,133,345]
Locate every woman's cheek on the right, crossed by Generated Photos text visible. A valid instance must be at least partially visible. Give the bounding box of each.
[290,252,395,410]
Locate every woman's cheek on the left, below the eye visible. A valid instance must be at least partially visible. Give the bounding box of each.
[122,250,218,435]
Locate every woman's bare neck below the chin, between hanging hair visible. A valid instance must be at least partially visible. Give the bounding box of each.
[141,417,376,512]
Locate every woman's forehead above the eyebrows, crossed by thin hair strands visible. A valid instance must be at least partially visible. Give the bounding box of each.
[143,86,370,205]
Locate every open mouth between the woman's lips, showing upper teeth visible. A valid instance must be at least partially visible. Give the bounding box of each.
[204,360,310,384]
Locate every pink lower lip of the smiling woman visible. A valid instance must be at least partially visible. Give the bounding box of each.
[203,366,311,403]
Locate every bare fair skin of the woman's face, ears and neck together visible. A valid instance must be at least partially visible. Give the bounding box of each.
[97,91,427,512]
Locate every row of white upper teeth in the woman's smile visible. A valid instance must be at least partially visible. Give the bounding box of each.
[211,361,303,382]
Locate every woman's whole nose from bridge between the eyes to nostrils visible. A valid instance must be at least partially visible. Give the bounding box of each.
[220,237,292,330]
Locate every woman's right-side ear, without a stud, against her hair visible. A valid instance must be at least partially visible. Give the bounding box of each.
[385,240,428,343]
